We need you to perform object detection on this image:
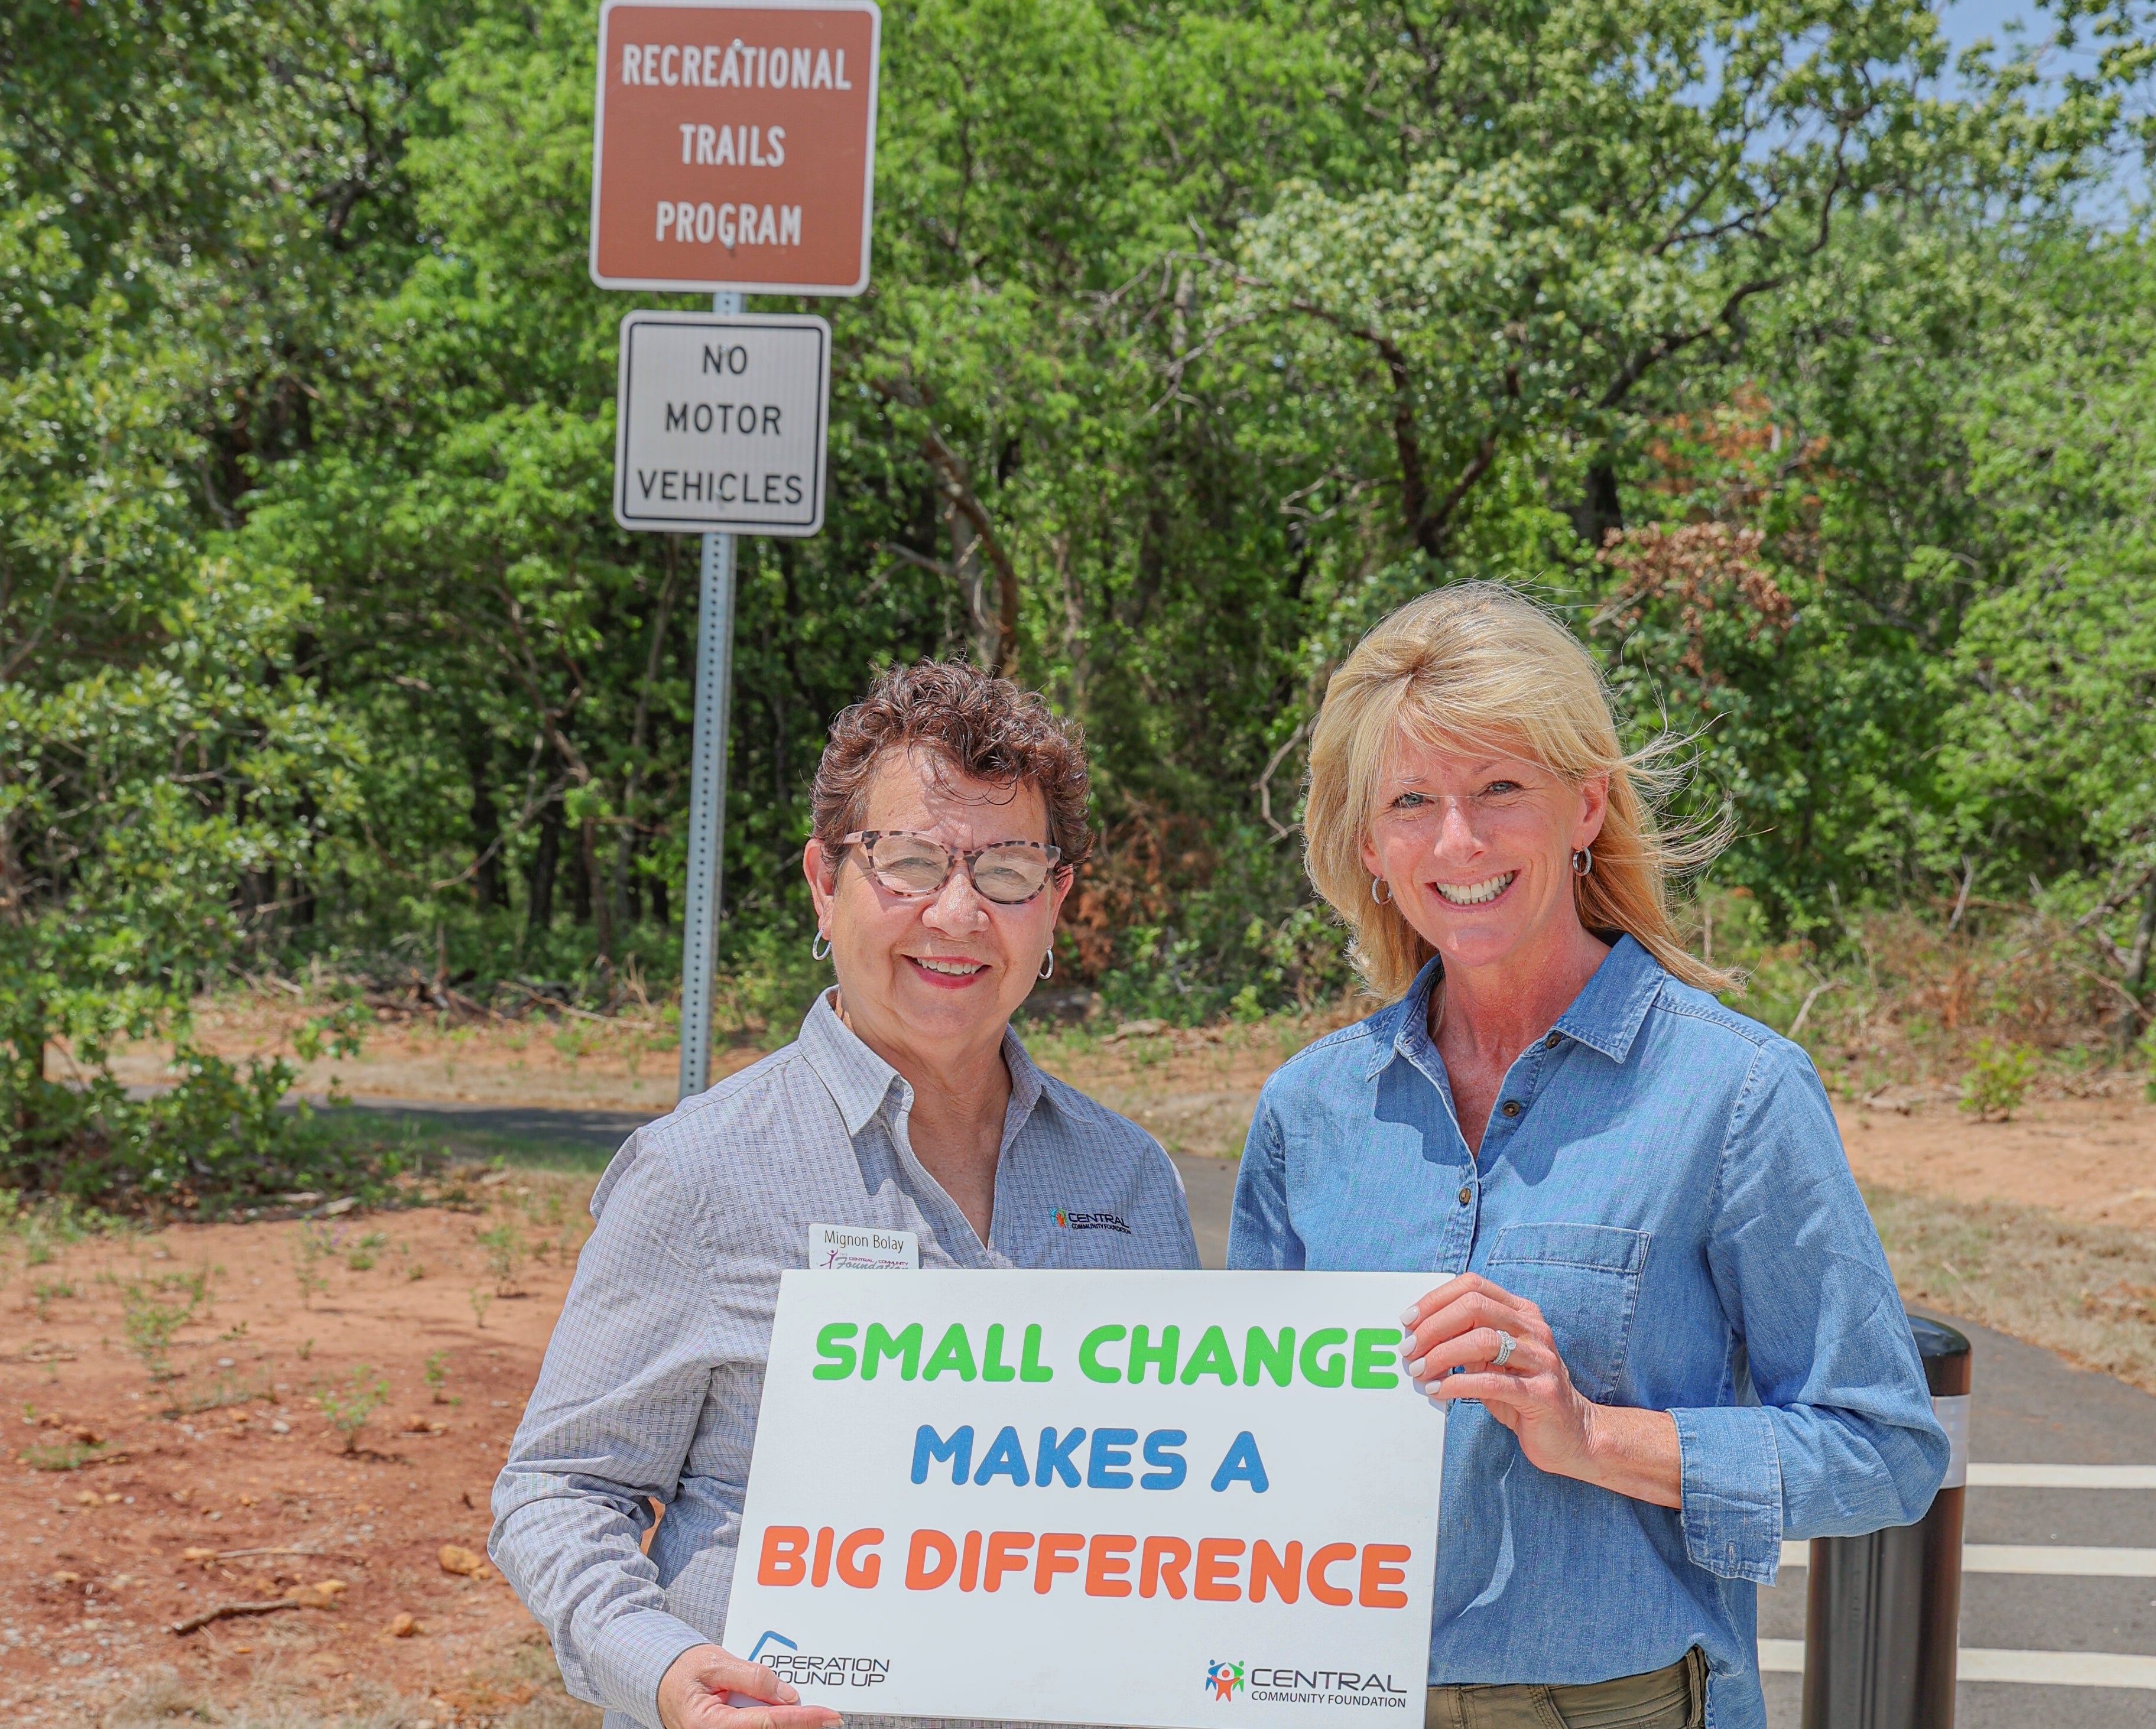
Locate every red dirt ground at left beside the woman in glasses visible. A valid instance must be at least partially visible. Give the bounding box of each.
[0,1175,597,1729]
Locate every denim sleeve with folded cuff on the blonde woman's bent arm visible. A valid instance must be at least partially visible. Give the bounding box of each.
[1671,1041,1947,1585]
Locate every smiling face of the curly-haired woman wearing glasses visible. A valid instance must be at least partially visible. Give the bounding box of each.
[802,750,1071,1074]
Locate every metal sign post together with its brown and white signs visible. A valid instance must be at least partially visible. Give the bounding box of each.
[591,0,882,1097]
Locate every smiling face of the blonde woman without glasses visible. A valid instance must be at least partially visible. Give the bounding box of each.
[1363,731,1608,970]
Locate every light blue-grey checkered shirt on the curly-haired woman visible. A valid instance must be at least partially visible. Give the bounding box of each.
[487,998,1199,1729]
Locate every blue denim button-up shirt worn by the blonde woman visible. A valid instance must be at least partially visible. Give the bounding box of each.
[1227,938,1947,1729]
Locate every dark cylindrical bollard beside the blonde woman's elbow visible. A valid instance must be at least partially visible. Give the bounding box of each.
[1804,1315,1969,1729]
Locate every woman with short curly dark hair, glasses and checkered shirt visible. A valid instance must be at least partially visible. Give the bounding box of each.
[489,662,1199,1729]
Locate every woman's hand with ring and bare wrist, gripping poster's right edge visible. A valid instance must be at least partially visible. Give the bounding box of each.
[1400,1272,1684,1507]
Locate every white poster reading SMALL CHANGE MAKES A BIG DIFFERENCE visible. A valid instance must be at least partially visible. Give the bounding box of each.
[726,1270,1444,1729]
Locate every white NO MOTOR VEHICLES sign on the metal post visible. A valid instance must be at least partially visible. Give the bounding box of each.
[615,313,830,535]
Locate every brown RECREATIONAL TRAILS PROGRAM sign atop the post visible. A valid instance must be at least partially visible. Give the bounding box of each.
[591,0,882,295]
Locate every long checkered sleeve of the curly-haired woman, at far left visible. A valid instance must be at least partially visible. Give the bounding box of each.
[487,1143,712,1725]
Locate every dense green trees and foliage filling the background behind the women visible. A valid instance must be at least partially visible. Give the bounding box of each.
[12,0,2156,1103]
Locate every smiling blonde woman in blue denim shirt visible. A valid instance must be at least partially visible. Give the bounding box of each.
[1229,582,1949,1729]
